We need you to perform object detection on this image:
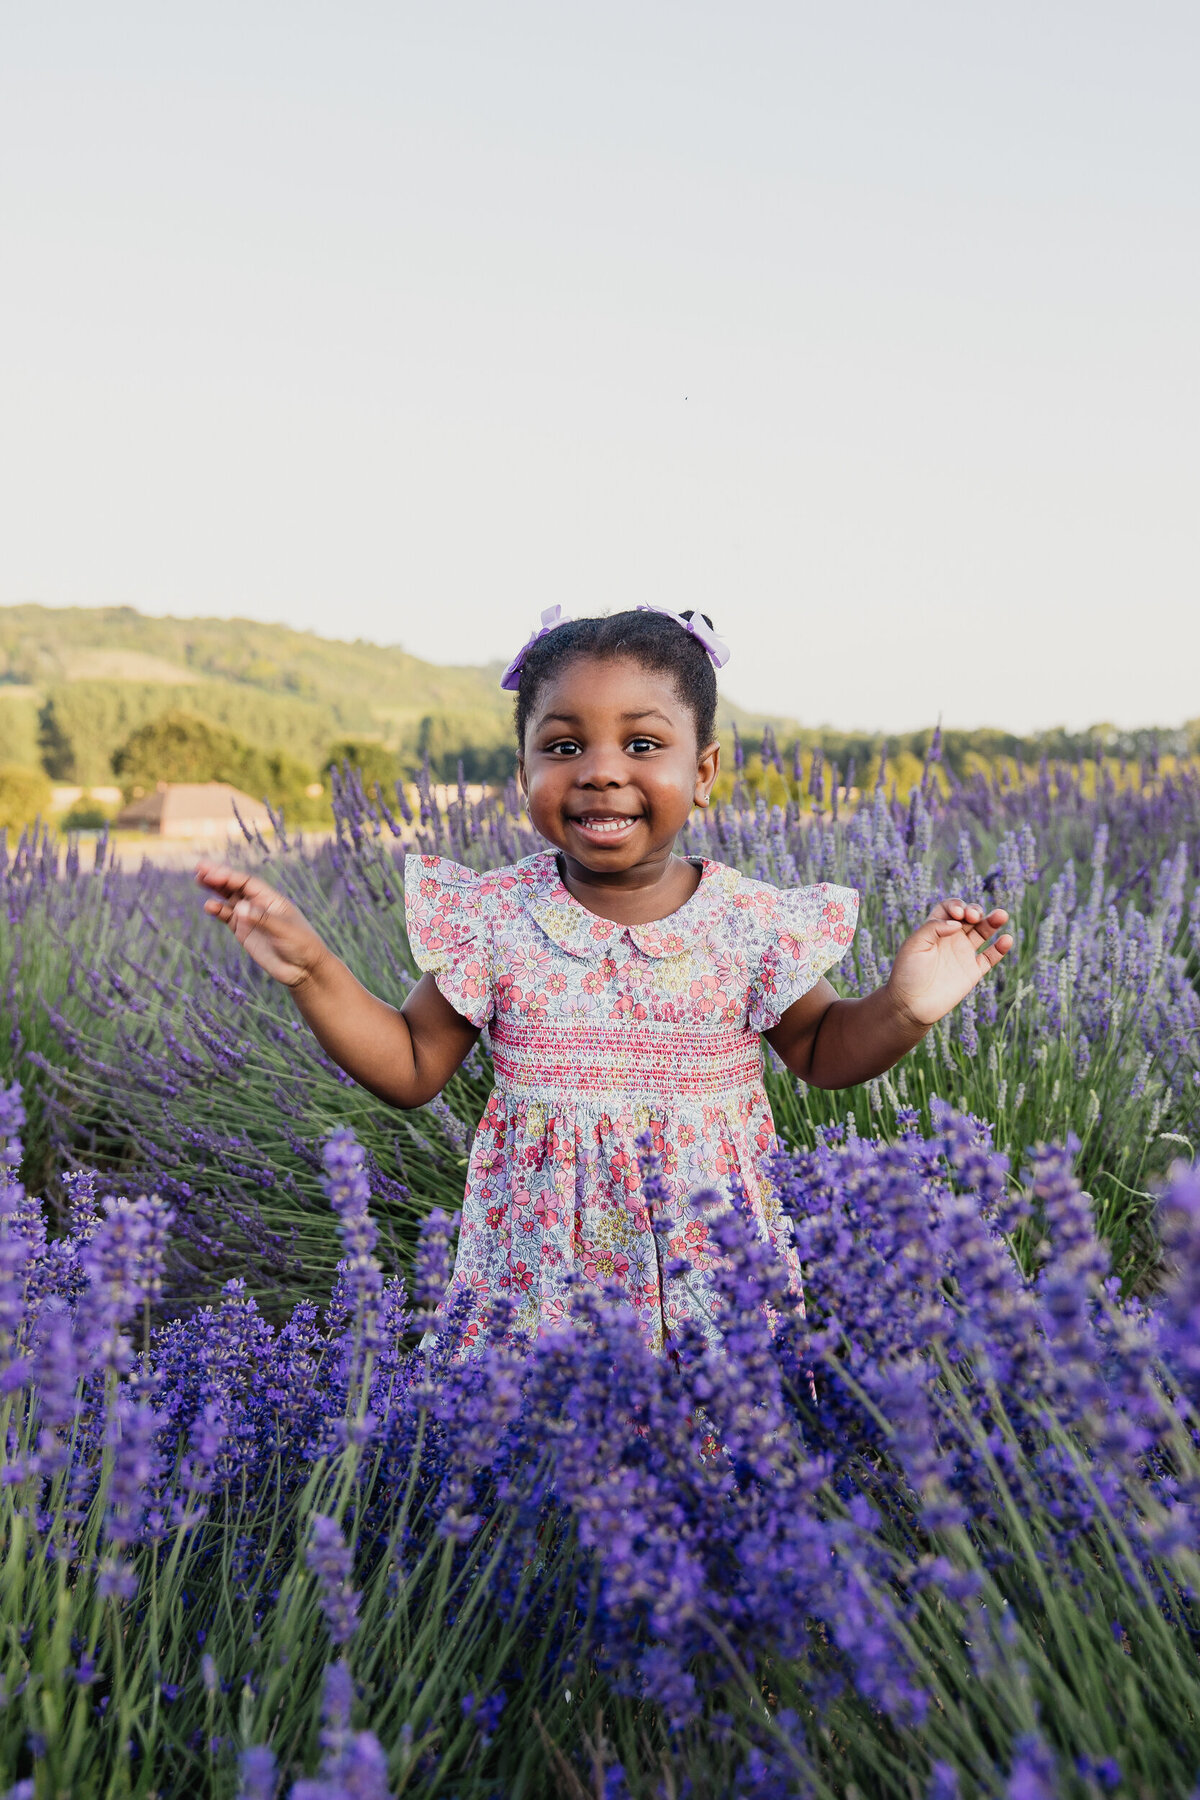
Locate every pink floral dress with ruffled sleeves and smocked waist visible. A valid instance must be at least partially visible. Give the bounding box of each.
[405,851,858,1350]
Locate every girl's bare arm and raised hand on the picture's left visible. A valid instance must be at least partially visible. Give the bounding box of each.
[196,862,479,1107]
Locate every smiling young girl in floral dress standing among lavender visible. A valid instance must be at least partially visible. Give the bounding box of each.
[196,607,1013,1348]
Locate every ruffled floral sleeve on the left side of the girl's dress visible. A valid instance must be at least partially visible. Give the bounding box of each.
[405,857,493,1030]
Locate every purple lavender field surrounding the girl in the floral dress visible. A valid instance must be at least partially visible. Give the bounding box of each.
[0,742,1200,1800]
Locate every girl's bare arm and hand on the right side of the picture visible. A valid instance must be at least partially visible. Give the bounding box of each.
[766,900,1013,1087]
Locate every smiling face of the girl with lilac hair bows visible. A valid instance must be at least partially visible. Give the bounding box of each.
[518,657,720,875]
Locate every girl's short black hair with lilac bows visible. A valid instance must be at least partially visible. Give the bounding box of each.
[516,612,716,751]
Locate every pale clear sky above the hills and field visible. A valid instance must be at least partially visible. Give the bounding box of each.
[0,0,1200,731]
